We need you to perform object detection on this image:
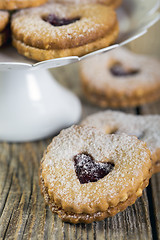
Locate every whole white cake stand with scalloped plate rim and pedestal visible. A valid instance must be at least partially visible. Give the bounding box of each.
[0,0,160,142]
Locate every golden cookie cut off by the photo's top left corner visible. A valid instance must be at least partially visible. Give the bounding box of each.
[0,0,47,10]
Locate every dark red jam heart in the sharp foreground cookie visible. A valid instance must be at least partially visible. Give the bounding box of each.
[74,153,114,184]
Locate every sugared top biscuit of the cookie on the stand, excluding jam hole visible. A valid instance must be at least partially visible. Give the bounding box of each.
[12,3,117,50]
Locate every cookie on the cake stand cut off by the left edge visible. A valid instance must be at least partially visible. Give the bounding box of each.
[0,10,9,46]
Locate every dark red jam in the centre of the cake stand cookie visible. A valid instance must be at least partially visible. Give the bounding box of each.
[43,14,80,27]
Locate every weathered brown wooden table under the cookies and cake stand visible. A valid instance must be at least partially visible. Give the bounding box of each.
[0,21,160,240]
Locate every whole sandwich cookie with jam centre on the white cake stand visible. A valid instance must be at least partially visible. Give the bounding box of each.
[12,3,118,61]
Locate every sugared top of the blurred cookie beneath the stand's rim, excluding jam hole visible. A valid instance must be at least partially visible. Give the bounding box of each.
[81,48,160,93]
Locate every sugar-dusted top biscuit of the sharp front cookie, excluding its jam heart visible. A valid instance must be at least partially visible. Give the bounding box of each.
[42,126,151,213]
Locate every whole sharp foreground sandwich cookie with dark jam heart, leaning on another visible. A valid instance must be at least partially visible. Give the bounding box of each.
[40,126,151,223]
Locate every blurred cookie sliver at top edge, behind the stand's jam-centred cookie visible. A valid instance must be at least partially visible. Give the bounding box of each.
[54,0,122,8]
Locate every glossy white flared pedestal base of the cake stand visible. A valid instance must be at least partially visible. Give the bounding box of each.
[0,70,81,142]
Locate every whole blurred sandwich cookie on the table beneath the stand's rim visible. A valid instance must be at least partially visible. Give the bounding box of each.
[80,48,160,108]
